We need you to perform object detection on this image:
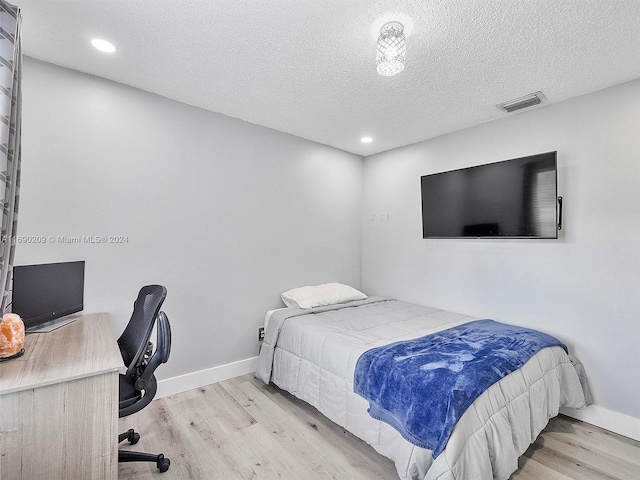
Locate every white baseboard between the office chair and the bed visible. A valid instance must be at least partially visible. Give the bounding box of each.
[155,357,258,398]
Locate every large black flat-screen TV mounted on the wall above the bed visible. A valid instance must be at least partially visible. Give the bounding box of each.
[421,152,558,238]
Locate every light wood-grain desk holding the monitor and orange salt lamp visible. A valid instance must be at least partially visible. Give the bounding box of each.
[0,314,122,480]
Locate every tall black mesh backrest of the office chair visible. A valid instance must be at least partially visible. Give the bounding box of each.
[118,285,167,380]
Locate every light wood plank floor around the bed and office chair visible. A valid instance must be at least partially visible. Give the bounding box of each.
[119,375,640,480]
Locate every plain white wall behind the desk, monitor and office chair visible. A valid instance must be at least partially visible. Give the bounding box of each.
[16,58,362,378]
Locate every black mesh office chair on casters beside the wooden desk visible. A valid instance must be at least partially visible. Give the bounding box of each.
[118,285,171,472]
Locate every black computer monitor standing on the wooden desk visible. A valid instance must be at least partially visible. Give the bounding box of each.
[12,261,84,329]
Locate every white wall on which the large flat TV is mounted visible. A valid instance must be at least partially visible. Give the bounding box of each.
[363,81,640,418]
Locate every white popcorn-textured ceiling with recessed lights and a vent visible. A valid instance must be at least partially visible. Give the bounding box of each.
[14,0,640,156]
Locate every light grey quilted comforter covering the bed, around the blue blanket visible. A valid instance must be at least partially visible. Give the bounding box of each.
[256,286,585,480]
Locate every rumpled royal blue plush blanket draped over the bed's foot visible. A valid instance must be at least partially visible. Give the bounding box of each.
[354,320,567,458]
